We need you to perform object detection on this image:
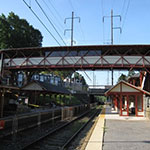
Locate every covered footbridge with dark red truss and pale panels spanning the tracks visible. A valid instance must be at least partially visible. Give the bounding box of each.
[0,45,150,72]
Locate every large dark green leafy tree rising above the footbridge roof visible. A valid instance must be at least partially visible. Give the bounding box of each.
[0,12,43,49]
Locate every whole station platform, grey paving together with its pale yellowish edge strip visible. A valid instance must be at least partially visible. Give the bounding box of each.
[86,106,150,150]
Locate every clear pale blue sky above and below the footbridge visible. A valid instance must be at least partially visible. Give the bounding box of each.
[0,0,150,85]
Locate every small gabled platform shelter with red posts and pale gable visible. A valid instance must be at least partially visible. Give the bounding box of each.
[105,81,150,117]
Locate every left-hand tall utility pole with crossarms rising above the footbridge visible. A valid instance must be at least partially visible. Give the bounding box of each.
[64,12,80,46]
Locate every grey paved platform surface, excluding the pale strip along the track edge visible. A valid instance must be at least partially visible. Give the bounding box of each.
[103,107,150,150]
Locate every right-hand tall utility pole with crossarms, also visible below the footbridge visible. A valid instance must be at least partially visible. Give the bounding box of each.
[103,10,122,85]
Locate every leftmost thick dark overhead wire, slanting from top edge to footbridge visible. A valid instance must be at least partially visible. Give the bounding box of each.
[23,0,61,46]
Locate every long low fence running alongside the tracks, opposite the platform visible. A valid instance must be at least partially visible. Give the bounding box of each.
[0,104,96,137]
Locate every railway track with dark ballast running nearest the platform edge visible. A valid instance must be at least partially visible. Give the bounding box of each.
[23,109,99,150]
